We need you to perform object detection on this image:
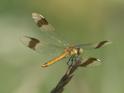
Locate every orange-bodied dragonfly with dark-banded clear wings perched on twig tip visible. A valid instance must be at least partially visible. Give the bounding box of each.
[22,12,110,67]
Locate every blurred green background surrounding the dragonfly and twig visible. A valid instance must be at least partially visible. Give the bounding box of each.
[0,0,124,93]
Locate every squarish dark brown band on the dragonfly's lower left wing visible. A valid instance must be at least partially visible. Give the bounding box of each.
[26,36,40,50]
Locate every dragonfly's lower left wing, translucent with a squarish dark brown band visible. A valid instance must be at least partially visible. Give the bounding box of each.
[21,36,64,54]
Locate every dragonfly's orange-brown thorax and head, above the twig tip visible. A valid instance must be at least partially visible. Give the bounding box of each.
[65,47,83,55]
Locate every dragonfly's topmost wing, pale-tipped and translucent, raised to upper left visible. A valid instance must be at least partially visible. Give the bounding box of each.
[32,13,69,46]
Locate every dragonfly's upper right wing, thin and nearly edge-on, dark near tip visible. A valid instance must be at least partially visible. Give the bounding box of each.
[75,40,111,49]
